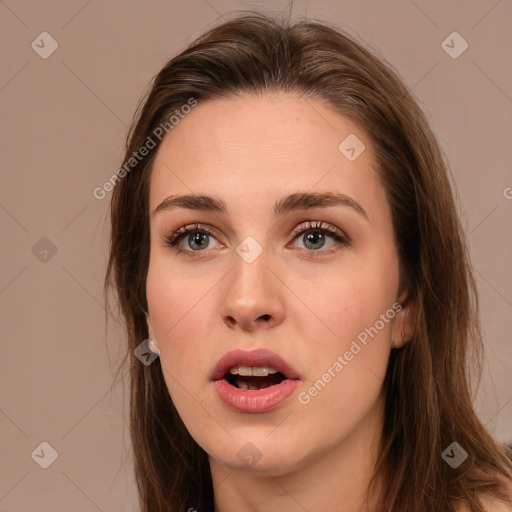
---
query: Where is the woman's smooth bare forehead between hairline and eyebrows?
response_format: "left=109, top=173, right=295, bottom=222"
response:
left=150, top=95, right=386, bottom=226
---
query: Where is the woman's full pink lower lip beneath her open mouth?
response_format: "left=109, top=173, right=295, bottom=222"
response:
left=214, top=379, right=299, bottom=413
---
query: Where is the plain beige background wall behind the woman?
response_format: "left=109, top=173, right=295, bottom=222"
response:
left=0, top=0, right=512, bottom=512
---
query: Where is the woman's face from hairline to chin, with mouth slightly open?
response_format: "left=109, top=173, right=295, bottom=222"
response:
left=147, top=95, right=409, bottom=475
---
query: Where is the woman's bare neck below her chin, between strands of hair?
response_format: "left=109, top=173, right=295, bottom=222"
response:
left=210, top=390, right=384, bottom=512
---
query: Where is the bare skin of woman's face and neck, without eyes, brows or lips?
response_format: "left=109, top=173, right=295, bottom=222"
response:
left=147, top=94, right=414, bottom=512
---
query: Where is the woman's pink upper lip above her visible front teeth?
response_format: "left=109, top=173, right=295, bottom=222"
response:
left=211, top=348, right=300, bottom=380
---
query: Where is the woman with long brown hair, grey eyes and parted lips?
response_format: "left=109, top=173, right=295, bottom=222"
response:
left=106, top=9, right=512, bottom=512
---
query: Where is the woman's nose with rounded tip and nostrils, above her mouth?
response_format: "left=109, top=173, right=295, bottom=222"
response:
left=221, top=251, right=285, bottom=331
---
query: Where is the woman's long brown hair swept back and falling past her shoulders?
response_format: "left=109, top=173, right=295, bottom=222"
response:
left=105, top=12, right=512, bottom=512
